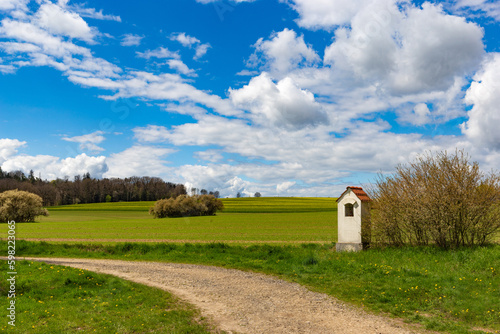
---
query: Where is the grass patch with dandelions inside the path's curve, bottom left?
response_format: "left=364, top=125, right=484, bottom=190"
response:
left=0, top=261, right=219, bottom=334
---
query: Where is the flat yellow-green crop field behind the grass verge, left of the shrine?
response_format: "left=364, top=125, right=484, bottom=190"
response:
left=7, top=198, right=337, bottom=243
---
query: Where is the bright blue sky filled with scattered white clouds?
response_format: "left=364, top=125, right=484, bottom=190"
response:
left=0, top=0, right=500, bottom=196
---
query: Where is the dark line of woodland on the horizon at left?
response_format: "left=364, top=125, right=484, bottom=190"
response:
left=0, top=168, right=187, bottom=206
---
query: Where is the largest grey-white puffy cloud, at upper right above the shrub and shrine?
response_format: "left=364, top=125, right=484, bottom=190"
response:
left=325, top=3, right=484, bottom=95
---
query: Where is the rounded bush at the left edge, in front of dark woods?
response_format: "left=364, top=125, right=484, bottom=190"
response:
left=0, top=190, right=49, bottom=223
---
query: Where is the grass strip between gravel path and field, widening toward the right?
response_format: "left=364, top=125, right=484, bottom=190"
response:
left=7, top=241, right=500, bottom=334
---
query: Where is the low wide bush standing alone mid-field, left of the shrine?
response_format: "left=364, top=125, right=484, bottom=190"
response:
left=149, top=195, right=224, bottom=218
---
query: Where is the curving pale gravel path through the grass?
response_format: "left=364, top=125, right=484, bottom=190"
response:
left=26, top=258, right=417, bottom=334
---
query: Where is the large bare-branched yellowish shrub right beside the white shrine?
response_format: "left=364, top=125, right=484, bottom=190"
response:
left=371, top=151, right=500, bottom=248
